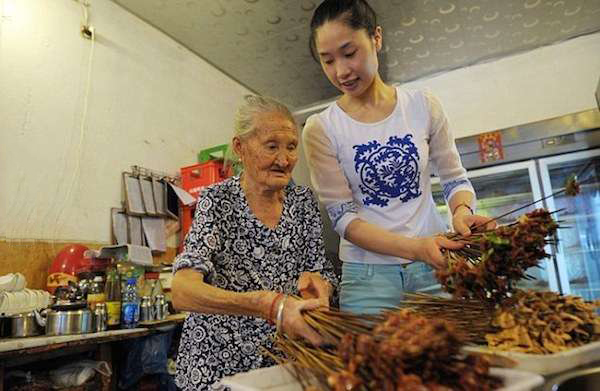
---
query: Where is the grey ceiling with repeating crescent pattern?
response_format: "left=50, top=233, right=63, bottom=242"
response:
left=113, top=0, right=600, bottom=108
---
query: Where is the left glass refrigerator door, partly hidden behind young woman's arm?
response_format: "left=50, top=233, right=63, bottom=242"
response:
left=432, top=161, right=558, bottom=291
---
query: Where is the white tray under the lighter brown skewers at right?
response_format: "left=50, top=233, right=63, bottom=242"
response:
left=463, top=341, right=600, bottom=375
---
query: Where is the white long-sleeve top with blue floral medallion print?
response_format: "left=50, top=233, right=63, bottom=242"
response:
left=302, top=88, right=475, bottom=264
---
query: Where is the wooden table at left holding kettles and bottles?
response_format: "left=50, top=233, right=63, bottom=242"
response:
left=0, top=314, right=186, bottom=391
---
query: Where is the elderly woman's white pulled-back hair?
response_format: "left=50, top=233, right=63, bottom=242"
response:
left=226, top=95, right=296, bottom=166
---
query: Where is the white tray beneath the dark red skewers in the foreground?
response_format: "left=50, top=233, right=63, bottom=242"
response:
left=221, top=365, right=544, bottom=391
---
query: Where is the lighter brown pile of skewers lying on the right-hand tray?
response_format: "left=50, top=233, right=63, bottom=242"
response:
left=402, top=290, right=600, bottom=354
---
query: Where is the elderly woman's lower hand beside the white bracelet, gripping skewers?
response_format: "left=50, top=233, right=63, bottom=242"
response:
left=281, top=297, right=323, bottom=346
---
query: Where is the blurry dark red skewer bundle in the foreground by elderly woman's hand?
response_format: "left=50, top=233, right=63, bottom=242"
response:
left=271, top=309, right=502, bottom=391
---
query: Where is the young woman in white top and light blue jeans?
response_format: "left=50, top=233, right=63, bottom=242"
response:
left=303, top=0, right=489, bottom=313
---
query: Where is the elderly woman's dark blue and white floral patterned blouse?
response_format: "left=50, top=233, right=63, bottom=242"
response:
left=174, top=177, right=336, bottom=391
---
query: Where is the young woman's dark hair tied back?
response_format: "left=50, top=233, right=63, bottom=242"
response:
left=309, top=0, right=377, bottom=62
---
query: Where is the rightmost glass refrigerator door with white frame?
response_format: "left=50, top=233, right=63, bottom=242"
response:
left=540, top=150, right=600, bottom=300
